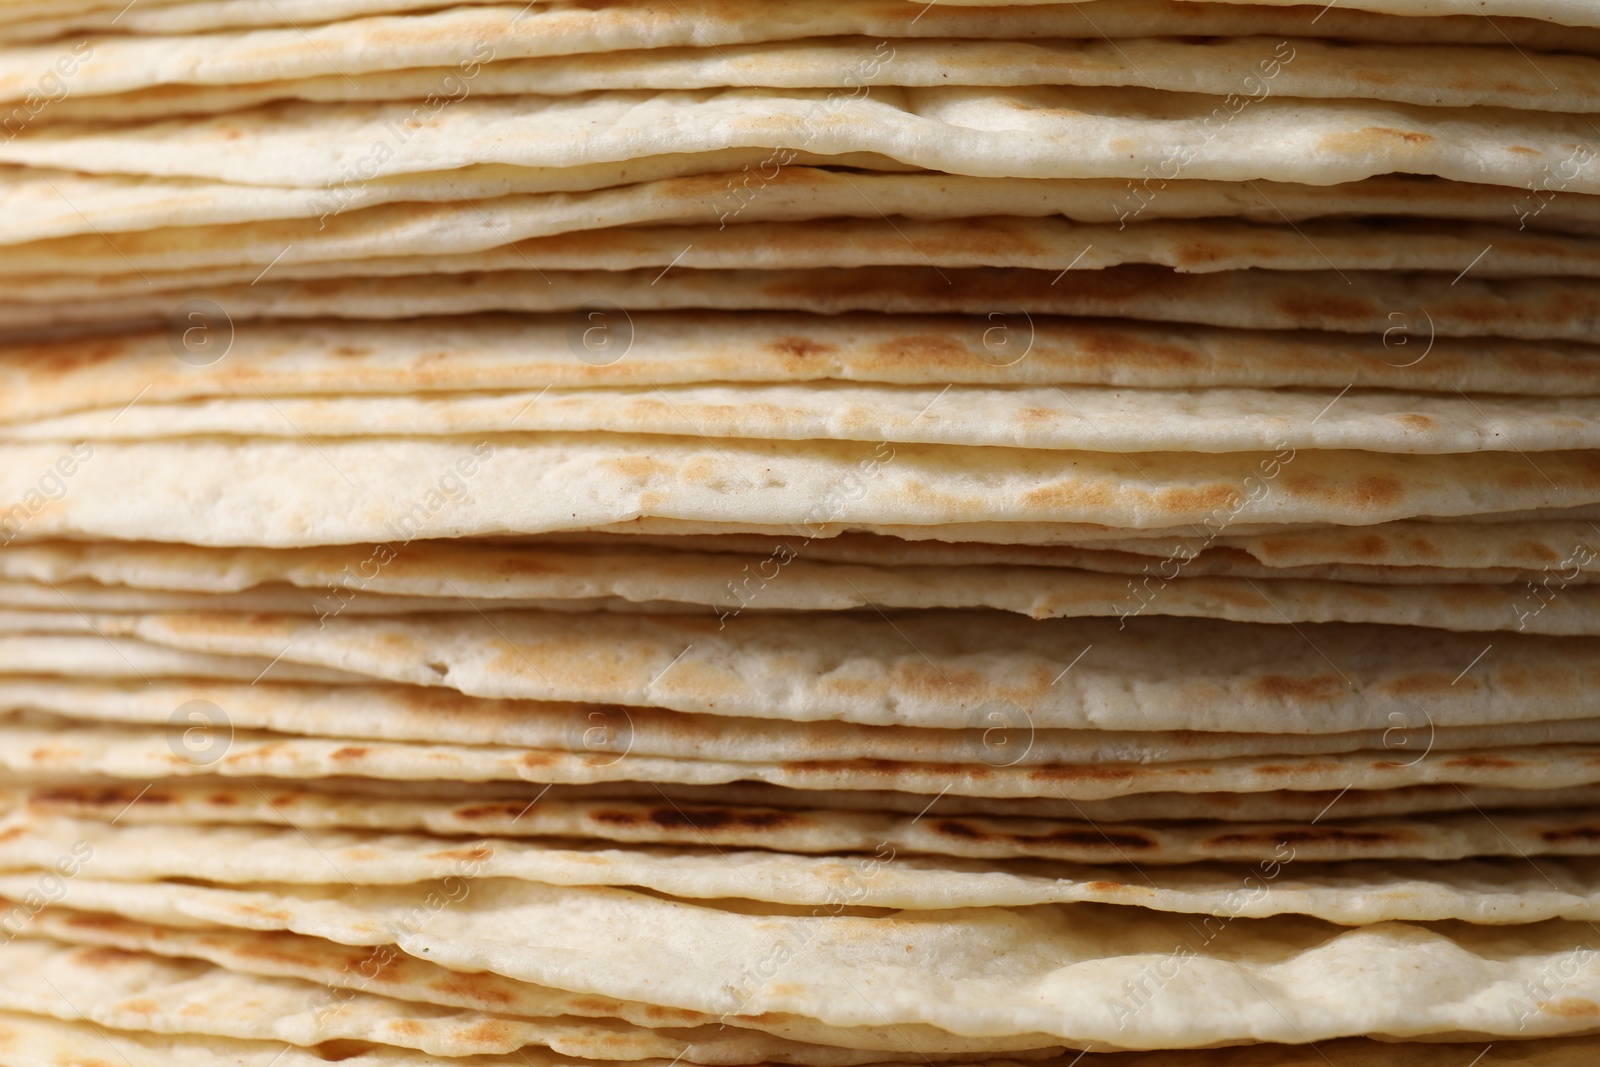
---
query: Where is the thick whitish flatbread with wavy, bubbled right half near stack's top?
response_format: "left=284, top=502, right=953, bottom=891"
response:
left=0, top=88, right=1600, bottom=194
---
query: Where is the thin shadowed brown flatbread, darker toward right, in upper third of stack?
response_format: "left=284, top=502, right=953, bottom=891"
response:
left=0, top=264, right=1600, bottom=337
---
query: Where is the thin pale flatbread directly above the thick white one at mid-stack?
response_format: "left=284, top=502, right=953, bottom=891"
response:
left=9, top=382, right=1600, bottom=454
